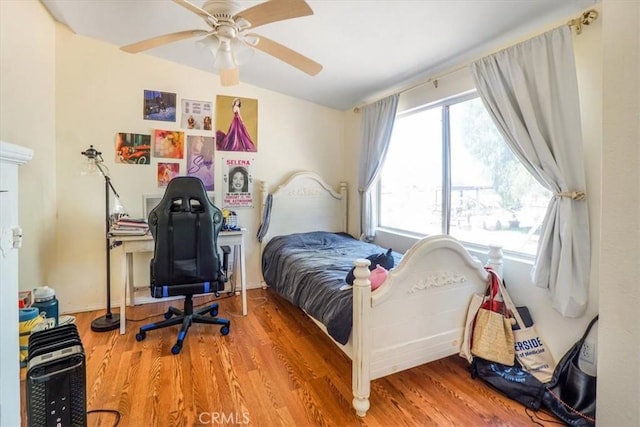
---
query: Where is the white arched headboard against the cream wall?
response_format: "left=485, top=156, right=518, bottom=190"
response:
left=260, top=171, right=347, bottom=245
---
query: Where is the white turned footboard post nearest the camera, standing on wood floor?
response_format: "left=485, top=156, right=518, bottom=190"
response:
left=351, top=259, right=373, bottom=417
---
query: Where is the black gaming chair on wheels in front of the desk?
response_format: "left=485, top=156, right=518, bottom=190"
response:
left=136, top=176, right=231, bottom=354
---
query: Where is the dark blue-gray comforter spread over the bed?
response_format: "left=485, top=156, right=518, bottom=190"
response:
left=262, top=231, right=401, bottom=344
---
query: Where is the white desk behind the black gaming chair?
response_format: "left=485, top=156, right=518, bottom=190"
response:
left=111, top=230, right=247, bottom=334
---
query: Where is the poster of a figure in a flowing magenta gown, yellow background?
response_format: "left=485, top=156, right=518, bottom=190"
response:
left=216, top=95, right=258, bottom=152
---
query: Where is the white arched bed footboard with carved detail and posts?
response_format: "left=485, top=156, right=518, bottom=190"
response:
left=351, top=236, right=502, bottom=417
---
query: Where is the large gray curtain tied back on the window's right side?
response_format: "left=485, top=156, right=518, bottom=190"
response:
left=471, top=26, right=591, bottom=317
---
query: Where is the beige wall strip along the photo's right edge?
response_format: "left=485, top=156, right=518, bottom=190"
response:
left=598, top=0, right=640, bottom=427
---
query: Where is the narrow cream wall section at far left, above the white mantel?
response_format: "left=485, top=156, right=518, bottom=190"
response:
left=0, top=0, right=56, bottom=289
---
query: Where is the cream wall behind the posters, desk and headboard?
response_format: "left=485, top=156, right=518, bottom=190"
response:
left=51, top=25, right=344, bottom=311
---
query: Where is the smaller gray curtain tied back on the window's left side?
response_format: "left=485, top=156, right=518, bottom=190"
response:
left=358, top=94, right=400, bottom=240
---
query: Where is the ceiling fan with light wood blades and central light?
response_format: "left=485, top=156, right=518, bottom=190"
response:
left=120, top=0, right=322, bottom=86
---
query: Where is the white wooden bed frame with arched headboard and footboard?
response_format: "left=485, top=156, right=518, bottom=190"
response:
left=261, top=172, right=502, bottom=417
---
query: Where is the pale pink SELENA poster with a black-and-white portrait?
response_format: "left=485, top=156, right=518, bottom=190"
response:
left=222, top=158, right=253, bottom=208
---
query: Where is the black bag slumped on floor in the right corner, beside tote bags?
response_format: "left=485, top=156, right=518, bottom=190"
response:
left=542, top=316, right=598, bottom=426
